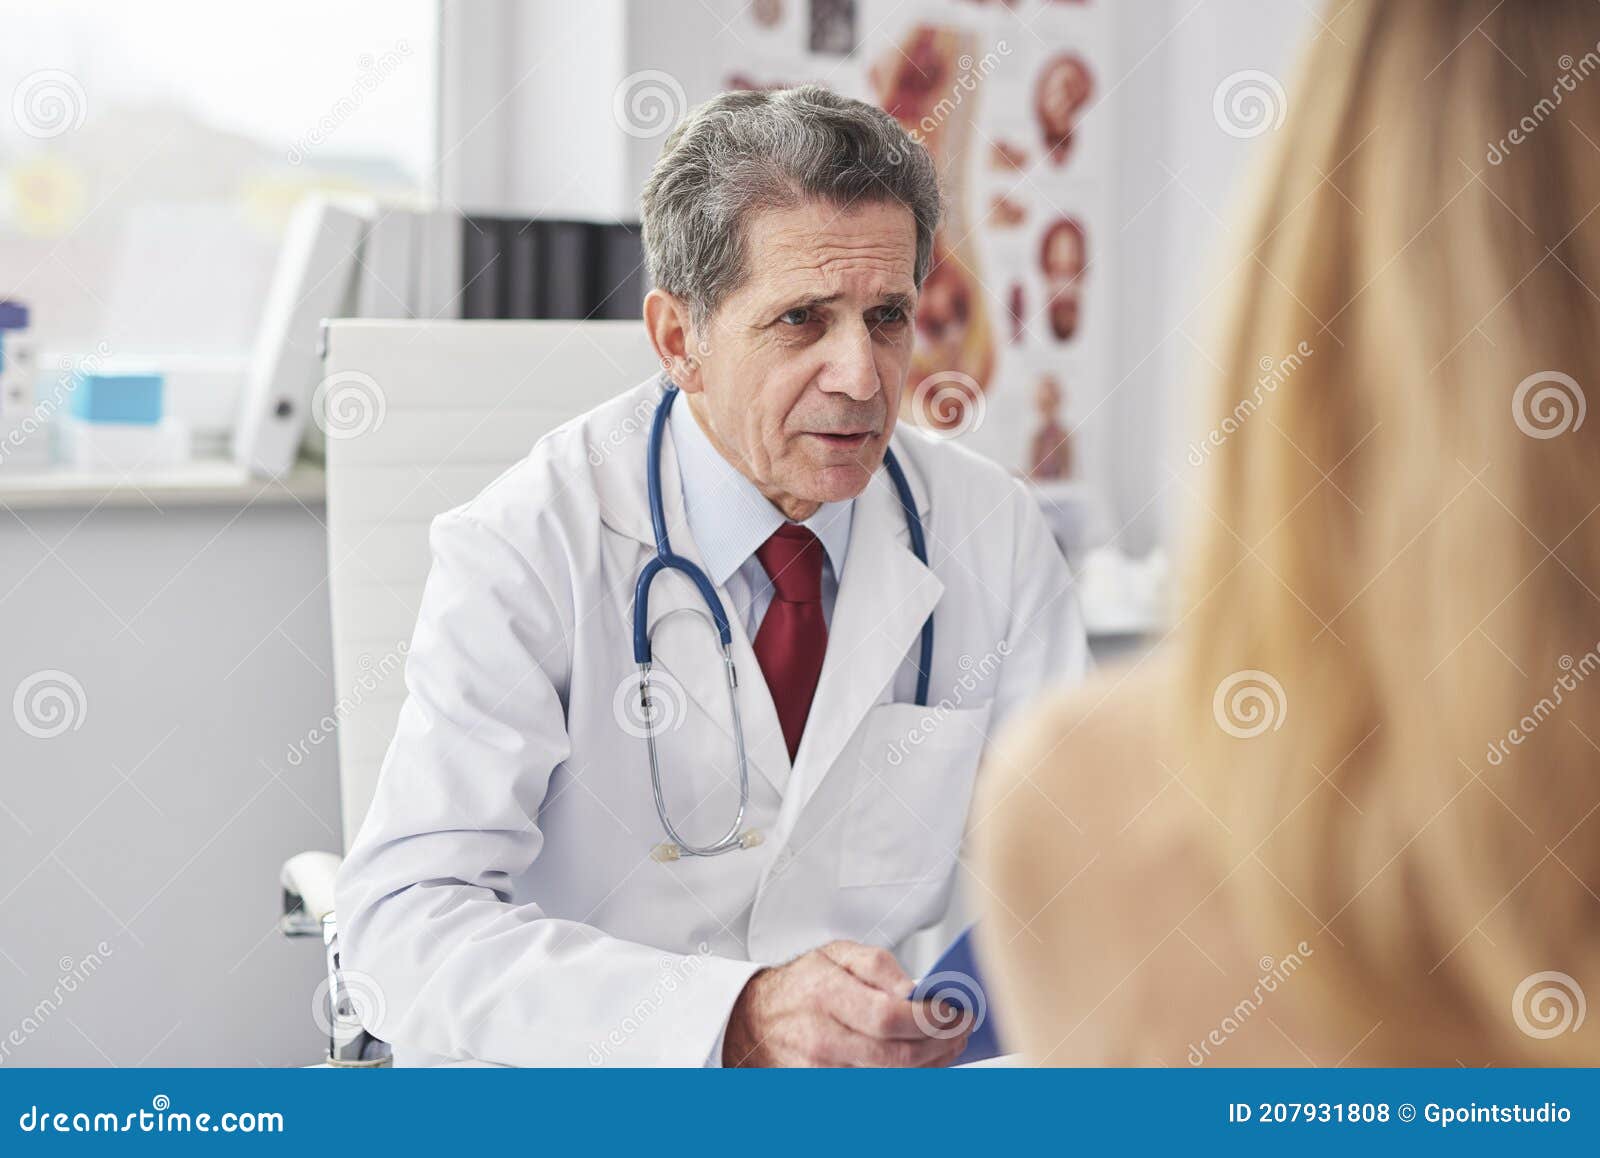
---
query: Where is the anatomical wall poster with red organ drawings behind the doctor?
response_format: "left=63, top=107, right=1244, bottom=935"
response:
left=624, top=0, right=1115, bottom=511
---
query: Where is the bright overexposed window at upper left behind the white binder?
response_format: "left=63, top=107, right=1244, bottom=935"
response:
left=0, top=0, right=438, bottom=449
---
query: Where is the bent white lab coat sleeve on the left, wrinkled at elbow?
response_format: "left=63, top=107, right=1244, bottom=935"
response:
left=336, top=512, right=760, bottom=1065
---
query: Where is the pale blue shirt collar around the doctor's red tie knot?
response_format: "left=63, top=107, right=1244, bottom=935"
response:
left=667, top=398, right=856, bottom=587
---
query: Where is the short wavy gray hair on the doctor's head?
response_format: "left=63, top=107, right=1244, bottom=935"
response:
left=640, top=85, right=944, bottom=329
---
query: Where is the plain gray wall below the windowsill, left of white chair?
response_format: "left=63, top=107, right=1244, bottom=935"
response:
left=0, top=502, right=339, bottom=1065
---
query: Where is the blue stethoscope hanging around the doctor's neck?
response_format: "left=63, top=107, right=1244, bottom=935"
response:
left=634, top=382, right=933, bottom=861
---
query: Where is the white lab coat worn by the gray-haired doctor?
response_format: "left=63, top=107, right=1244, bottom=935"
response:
left=338, top=379, right=1086, bottom=1065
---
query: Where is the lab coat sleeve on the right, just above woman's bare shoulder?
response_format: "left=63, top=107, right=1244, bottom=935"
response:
left=989, top=483, right=1090, bottom=736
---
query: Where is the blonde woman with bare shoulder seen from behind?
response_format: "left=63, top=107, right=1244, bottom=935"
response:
left=974, top=0, right=1600, bottom=1065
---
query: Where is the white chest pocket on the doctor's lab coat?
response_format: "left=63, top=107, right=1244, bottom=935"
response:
left=838, top=704, right=992, bottom=884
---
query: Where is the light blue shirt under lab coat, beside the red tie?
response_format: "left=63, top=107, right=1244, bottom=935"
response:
left=667, top=395, right=856, bottom=640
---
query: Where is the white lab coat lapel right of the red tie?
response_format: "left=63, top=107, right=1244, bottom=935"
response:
left=784, top=454, right=944, bottom=830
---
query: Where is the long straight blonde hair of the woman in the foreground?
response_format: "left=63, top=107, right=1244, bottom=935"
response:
left=1176, top=0, right=1600, bottom=1062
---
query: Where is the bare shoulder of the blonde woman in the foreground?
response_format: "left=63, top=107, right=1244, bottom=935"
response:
left=973, top=656, right=1324, bottom=1065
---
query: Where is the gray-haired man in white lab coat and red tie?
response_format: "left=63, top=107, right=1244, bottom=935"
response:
left=338, top=86, right=1086, bottom=1065
